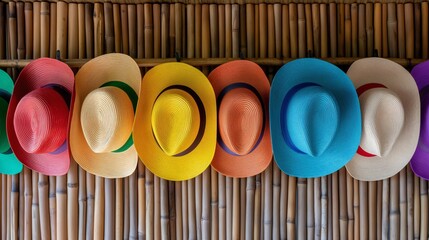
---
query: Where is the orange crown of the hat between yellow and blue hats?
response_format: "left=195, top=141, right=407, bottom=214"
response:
left=219, top=88, right=264, bottom=156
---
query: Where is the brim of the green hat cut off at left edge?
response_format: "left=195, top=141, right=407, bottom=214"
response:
left=0, top=70, right=23, bottom=174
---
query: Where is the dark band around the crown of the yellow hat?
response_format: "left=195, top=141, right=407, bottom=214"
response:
left=152, top=85, right=206, bottom=157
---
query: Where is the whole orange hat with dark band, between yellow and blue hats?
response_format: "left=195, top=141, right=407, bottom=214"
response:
left=208, top=60, right=272, bottom=177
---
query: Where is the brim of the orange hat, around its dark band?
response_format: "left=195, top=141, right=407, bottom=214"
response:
left=208, top=60, right=273, bottom=177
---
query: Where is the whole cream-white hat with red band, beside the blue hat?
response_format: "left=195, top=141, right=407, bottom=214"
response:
left=346, top=58, right=420, bottom=181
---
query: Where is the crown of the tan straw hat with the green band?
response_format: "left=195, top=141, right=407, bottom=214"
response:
left=80, top=86, right=134, bottom=153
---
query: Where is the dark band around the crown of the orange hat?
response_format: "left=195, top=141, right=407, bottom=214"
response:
left=217, top=82, right=266, bottom=156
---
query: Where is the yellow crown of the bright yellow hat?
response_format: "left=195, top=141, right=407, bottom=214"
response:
left=151, top=89, right=200, bottom=156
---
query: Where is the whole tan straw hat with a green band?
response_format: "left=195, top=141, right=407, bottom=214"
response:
left=70, top=53, right=141, bottom=178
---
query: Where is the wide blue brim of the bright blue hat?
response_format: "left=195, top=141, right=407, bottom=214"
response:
left=270, top=59, right=361, bottom=178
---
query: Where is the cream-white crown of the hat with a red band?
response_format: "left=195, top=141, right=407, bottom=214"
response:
left=359, top=88, right=405, bottom=157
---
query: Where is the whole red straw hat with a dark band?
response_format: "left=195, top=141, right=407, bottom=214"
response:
left=6, top=58, right=74, bottom=176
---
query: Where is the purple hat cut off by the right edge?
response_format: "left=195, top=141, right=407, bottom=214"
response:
left=410, top=61, right=429, bottom=180
